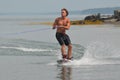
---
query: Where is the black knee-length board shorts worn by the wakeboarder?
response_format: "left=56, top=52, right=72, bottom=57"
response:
left=56, top=32, right=71, bottom=46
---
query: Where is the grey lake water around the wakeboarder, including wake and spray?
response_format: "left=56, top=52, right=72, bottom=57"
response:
left=0, top=15, right=120, bottom=80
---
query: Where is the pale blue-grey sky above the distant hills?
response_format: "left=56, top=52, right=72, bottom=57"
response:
left=0, top=0, right=120, bottom=13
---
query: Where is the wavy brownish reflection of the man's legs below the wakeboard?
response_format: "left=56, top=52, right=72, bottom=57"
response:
left=57, top=66, right=72, bottom=80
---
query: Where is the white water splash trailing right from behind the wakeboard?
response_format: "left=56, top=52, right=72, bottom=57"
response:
left=54, top=42, right=120, bottom=66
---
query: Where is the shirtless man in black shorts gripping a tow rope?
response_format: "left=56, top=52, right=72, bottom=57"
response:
left=53, top=8, right=72, bottom=60
